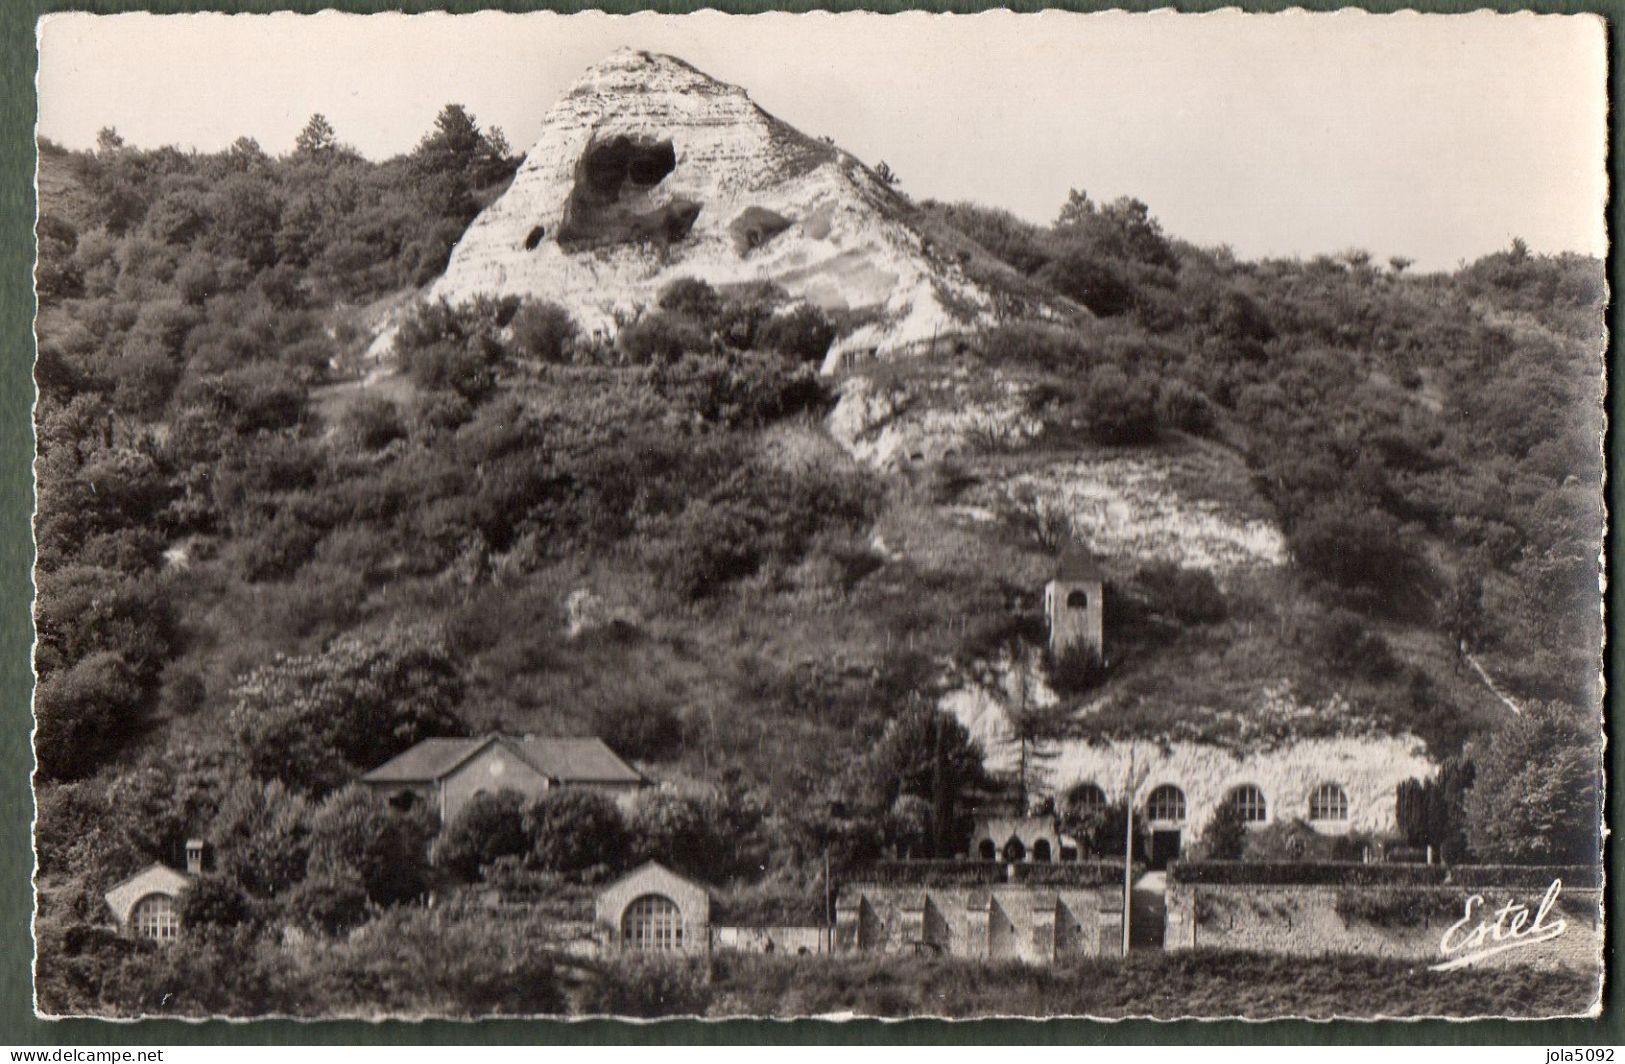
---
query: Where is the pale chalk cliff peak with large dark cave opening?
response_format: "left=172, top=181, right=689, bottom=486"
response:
left=431, top=50, right=993, bottom=367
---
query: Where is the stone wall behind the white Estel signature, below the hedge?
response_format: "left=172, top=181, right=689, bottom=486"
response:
left=1164, top=882, right=1602, bottom=971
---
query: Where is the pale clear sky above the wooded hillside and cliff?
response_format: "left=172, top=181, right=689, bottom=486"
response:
left=39, top=11, right=1607, bottom=270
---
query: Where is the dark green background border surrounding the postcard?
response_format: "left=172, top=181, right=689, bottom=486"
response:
left=0, top=0, right=1625, bottom=1061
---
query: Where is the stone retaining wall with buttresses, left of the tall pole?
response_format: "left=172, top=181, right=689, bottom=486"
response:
left=834, top=884, right=1123, bottom=963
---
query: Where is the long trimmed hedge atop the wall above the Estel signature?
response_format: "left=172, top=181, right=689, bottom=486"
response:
left=1168, top=861, right=1602, bottom=889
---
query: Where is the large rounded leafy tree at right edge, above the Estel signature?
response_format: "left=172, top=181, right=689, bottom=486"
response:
left=1466, top=702, right=1602, bottom=864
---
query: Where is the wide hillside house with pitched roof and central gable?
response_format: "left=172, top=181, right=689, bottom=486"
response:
left=361, top=734, right=648, bottom=822
